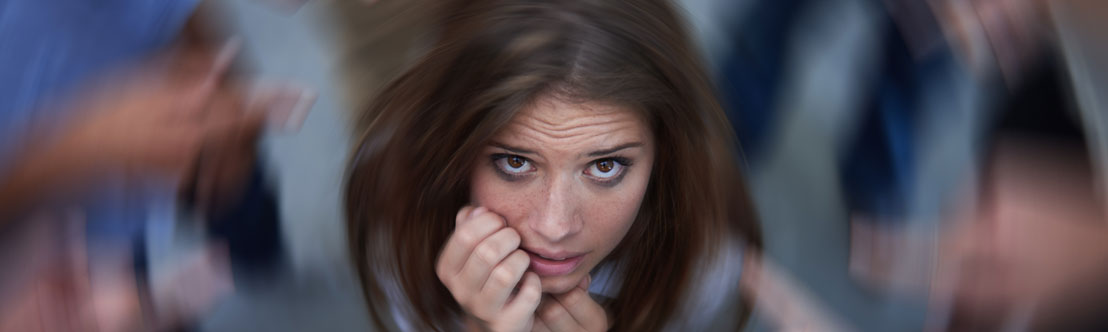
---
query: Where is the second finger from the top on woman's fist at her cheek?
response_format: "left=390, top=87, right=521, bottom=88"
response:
left=458, top=226, right=521, bottom=290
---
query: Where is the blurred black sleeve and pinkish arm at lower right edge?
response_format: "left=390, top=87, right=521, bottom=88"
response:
left=933, top=71, right=1108, bottom=331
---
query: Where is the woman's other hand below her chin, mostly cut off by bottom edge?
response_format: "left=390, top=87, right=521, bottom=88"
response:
left=532, top=277, right=608, bottom=331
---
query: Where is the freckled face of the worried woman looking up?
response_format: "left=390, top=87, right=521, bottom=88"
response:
left=471, top=97, right=654, bottom=293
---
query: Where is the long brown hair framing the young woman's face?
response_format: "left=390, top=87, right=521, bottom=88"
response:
left=346, top=0, right=761, bottom=331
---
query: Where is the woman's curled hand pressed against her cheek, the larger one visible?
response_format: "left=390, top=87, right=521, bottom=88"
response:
left=435, top=207, right=542, bottom=332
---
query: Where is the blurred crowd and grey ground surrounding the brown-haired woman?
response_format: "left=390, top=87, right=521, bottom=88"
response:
left=0, top=0, right=1108, bottom=331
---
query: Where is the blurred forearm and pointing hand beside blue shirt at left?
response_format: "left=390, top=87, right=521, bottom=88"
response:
left=0, top=39, right=315, bottom=221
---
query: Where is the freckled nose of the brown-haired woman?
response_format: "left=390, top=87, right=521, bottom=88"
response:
left=529, top=176, right=584, bottom=243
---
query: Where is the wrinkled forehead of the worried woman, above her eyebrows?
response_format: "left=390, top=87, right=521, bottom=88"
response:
left=496, top=97, right=652, bottom=148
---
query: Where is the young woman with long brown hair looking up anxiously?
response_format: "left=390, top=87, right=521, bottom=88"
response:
left=346, top=0, right=761, bottom=331
